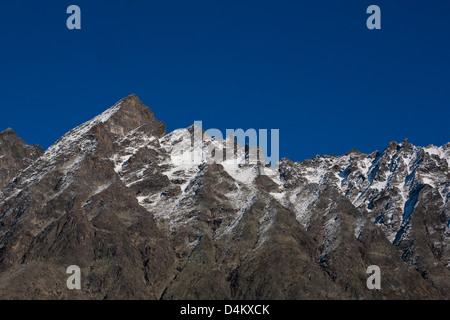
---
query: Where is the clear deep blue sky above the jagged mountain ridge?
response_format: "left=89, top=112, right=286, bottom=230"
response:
left=0, top=0, right=450, bottom=160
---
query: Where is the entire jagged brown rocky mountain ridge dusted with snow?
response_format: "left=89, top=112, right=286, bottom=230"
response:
left=0, top=95, right=450, bottom=299
